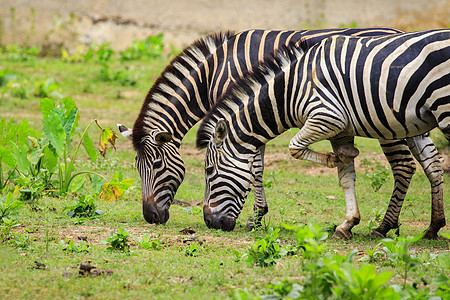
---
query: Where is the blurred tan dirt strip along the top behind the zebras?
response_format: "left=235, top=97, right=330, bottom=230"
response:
left=0, top=0, right=450, bottom=55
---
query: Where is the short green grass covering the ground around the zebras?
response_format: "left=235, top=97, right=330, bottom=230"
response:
left=0, top=45, right=450, bottom=299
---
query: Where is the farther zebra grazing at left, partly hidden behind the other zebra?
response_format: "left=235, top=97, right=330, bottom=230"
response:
left=119, top=28, right=442, bottom=234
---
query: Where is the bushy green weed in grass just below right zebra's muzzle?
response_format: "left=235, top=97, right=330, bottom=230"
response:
left=247, top=228, right=287, bottom=267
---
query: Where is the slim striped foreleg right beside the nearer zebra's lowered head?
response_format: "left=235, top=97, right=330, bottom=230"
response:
left=245, top=146, right=269, bottom=231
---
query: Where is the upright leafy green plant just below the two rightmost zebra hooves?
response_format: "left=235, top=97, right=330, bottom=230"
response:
left=381, top=234, right=424, bottom=287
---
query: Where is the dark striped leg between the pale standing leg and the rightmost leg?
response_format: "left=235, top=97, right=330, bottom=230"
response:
left=370, top=140, right=416, bottom=238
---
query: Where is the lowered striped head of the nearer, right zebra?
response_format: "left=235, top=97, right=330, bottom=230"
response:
left=197, top=119, right=262, bottom=231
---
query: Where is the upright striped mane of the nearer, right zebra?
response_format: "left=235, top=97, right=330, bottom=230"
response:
left=196, top=39, right=312, bottom=149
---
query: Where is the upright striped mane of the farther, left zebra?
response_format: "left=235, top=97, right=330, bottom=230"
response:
left=132, top=31, right=235, bottom=151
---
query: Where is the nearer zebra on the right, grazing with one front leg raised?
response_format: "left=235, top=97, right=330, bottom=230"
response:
left=197, top=29, right=450, bottom=239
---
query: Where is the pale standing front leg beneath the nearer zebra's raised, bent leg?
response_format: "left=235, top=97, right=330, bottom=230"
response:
left=331, top=137, right=361, bottom=239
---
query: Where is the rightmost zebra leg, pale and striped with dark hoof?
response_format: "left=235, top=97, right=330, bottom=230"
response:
left=406, top=134, right=445, bottom=239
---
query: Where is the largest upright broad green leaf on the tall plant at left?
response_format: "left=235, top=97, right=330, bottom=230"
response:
left=42, top=111, right=66, bottom=157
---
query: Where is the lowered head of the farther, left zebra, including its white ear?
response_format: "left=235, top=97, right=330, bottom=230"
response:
left=118, top=124, right=185, bottom=224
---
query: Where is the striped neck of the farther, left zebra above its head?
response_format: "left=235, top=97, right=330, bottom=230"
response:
left=135, top=45, right=221, bottom=147
